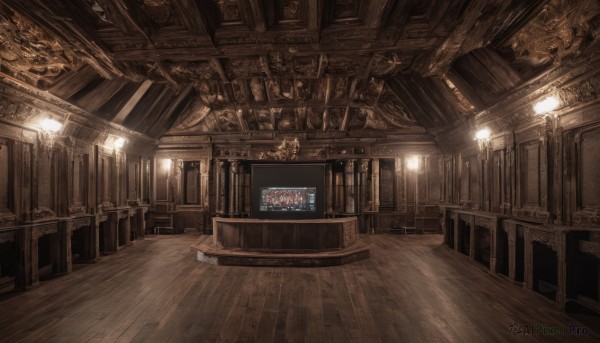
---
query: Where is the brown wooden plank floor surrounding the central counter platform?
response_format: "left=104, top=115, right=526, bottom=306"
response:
left=0, top=235, right=600, bottom=342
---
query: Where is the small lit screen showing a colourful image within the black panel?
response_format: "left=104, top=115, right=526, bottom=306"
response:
left=259, top=187, right=317, bottom=212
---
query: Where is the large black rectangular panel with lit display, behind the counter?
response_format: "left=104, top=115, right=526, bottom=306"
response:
left=251, top=163, right=325, bottom=219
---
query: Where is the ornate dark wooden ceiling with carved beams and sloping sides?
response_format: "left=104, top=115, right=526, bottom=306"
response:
left=0, top=0, right=598, bottom=144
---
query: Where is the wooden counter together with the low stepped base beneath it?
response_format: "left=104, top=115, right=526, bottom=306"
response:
left=192, top=217, right=370, bottom=267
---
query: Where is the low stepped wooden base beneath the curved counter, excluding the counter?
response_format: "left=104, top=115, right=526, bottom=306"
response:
left=192, top=236, right=371, bottom=267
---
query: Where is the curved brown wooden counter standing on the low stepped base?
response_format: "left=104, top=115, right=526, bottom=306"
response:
left=213, top=217, right=358, bottom=252
